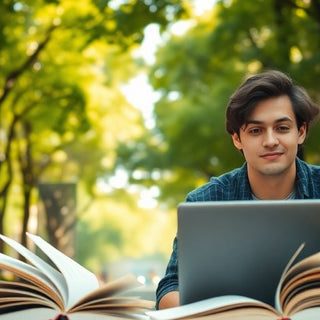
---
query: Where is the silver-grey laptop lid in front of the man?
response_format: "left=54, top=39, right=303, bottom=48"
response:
left=178, top=200, right=320, bottom=305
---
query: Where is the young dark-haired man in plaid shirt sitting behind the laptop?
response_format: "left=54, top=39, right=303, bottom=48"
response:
left=156, top=71, right=320, bottom=309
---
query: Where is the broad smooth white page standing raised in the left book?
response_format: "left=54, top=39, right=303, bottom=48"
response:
left=27, top=233, right=99, bottom=310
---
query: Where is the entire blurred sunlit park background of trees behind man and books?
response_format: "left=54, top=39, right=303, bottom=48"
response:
left=0, top=0, right=320, bottom=300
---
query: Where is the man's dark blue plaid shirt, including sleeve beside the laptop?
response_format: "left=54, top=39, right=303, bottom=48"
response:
left=156, top=158, right=320, bottom=308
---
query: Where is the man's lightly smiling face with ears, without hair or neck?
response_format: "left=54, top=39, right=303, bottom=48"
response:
left=232, top=96, right=306, bottom=176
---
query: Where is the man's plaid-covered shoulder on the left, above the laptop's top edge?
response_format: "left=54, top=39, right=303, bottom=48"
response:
left=187, top=164, right=251, bottom=201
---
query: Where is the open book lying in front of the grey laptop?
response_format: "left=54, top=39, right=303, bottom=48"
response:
left=147, top=245, right=320, bottom=320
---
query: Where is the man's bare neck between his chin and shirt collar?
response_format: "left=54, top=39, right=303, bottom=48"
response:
left=248, top=167, right=296, bottom=200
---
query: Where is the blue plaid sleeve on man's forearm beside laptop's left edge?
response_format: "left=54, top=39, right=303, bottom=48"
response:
left=156, top=237, right=179, bottom=309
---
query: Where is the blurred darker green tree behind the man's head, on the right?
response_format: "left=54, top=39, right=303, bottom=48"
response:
left=115, top=0, right=320, bottom=205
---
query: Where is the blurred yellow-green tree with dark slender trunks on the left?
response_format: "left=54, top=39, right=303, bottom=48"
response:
left=0, top=0, right=183, bottom=250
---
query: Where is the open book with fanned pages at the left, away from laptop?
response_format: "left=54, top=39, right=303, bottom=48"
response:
left=0, top=233, right=154, bottom=320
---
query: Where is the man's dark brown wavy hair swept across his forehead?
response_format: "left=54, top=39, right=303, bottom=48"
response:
left=226, top=70, right=319, bottom=135
